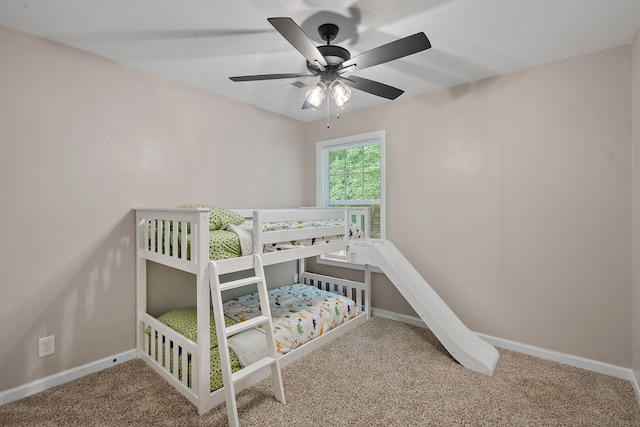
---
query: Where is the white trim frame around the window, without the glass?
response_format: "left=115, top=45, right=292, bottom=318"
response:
left=316, top=130, right=387, bottom=269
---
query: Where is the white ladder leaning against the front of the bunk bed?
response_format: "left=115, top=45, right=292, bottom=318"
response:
left=209, top=254, right=285, bottom=426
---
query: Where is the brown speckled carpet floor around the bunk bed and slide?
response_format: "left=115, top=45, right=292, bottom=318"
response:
left=0, top=317, right=640, bottom=426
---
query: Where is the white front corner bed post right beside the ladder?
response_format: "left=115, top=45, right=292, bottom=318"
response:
left=191, top=210, right=212, bottom=415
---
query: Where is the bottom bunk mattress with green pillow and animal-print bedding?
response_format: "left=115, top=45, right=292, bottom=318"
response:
left=146, top=284, right=358, bottom=391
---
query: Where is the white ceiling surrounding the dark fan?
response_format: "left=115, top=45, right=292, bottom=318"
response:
left=0, top=0, right=640, bottom=121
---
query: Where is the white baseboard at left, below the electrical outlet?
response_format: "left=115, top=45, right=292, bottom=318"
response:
left=0, top=350, right=136, bottom=405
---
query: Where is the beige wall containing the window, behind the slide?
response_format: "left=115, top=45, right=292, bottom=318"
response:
left=306, top=46, right=632, bottom=367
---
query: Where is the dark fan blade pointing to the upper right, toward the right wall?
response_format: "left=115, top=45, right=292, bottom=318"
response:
left=342, top=33, right=431, bottom=71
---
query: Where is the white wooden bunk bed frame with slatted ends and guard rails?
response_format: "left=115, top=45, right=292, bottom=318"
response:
left=136, top=208, right=371, bottom=420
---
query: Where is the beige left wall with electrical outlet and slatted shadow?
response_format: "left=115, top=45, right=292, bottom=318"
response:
left=0, top=27, right=304, bottom=390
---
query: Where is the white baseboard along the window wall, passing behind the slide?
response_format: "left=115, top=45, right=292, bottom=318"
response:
left=371, top=308, right=640, bottom=384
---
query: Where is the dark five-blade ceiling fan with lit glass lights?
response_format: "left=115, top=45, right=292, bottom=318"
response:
left=229, top=18, right=431, bottom=110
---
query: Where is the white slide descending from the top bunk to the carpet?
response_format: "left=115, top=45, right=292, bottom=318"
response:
left=349, top=239, right=500, bottom=375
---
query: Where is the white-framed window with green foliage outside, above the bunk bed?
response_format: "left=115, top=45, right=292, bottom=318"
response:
left=316, top=131, right=386, bottom=244
